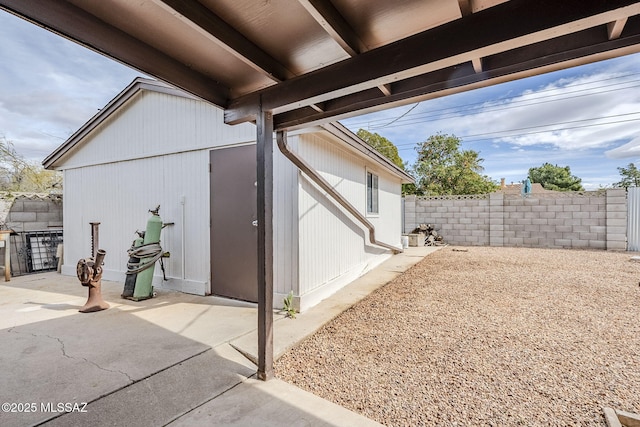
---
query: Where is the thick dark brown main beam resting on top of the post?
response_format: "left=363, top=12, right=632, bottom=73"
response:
left=225, top=0, right=640, bottom=124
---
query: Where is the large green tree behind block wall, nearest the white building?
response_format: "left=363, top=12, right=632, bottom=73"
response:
left=413, top=133, right=498, bottom=195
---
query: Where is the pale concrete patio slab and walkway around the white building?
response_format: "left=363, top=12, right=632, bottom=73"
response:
left=0, top=248, right=435, bottom=427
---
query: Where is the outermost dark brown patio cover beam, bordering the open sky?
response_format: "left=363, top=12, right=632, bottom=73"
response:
left=274, top=22, right=640, bottom=130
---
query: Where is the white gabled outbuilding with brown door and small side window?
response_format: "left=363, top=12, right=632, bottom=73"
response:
left=43, top=78, right=412, bottom=310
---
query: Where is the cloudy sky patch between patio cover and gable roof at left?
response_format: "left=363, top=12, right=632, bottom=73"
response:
left=0, top=11, right=139, bottom=161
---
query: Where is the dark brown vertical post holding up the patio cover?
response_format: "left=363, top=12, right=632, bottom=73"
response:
left=256, top=102, right=273, bottom=381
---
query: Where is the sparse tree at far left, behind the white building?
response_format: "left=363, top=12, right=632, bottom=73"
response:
left=0, top=136, right=62, bottom=192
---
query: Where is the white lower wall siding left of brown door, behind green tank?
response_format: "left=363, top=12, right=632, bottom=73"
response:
left=64, top=150, right=210, bottom=293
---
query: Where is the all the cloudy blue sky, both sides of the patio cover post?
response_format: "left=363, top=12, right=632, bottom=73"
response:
left=0, top=11, right=640, bottom=190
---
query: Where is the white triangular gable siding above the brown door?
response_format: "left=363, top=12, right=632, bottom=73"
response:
left=59, top=91, right=256, bottom=169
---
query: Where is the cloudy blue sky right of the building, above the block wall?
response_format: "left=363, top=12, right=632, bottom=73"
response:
left=344, top=55, right=640, bottom=188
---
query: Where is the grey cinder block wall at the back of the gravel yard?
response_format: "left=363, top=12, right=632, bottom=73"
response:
left=405, top=189, right=627, bottom=250
